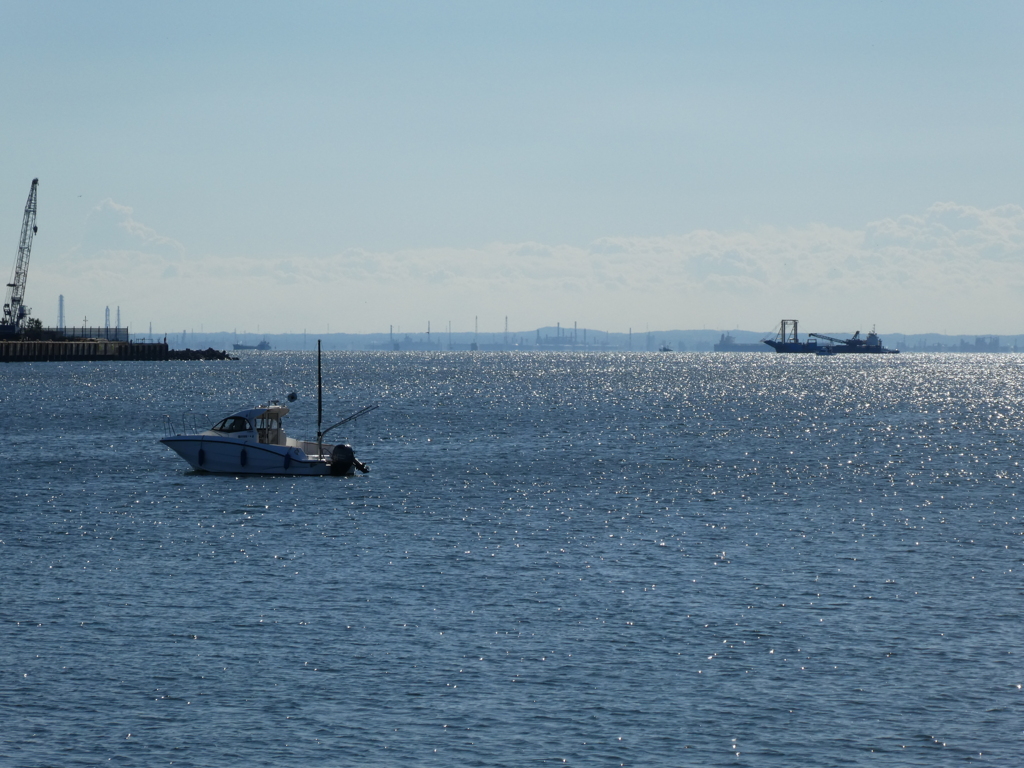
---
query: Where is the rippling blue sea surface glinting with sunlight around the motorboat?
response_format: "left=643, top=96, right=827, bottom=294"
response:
left=0, top=352, right=1024, bottom=766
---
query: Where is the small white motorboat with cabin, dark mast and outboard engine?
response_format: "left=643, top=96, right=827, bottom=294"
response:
left=161, top=342, right=377, bottom=475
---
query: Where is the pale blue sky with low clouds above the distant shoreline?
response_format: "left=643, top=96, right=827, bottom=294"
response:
left=0, top=0, right=1024, bottom=335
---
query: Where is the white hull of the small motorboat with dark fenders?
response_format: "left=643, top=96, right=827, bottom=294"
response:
left=161, top=435, right=352, bottom=475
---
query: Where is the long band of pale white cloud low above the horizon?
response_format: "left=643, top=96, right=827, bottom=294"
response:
left=25, top=201, right=1024, bottom=334
